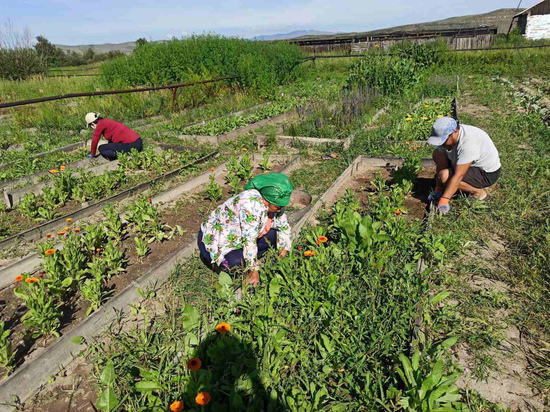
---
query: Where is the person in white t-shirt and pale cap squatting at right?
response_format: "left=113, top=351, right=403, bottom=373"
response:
left=428, top=117, right=500, bottom=214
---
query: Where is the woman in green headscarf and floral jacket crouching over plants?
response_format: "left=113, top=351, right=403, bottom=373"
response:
left=197, top=173, right=292, bottom=286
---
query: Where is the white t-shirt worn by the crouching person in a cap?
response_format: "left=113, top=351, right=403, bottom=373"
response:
left=438, top=124, right=500, bottom=173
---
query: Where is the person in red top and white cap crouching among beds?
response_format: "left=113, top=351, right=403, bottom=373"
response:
left=86, top=113, right=143, bottom=160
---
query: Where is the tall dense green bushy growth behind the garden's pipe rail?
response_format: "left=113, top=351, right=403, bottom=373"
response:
left=101, top=35, right=303, bottom=94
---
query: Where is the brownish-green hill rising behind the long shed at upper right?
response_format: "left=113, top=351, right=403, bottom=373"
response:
left=297, top=9, right=524, bottom=40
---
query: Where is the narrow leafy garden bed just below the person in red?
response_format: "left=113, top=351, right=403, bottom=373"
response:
left=0, top=148, right=218, bottom=248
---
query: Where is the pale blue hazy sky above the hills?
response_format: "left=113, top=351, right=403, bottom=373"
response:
left=0, top=0, right=539, bottom=45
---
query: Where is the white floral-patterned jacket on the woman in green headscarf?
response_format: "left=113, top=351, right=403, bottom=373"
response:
left=201, top=189, right=292, bottom=270
